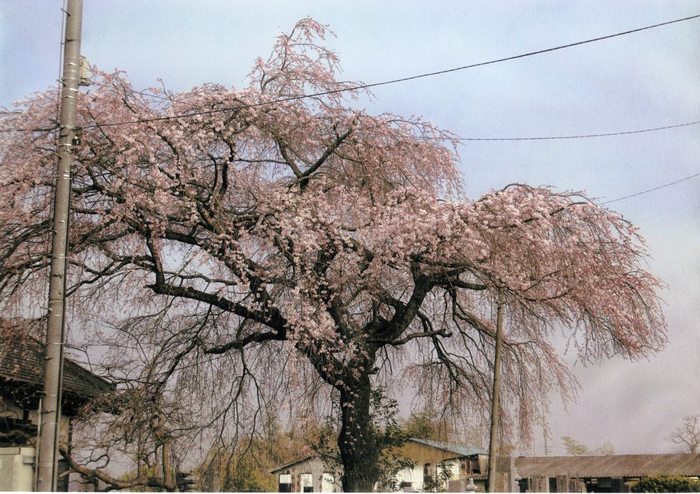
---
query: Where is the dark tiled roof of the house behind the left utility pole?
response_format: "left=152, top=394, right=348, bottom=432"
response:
left=0, top=332, right=115, bottom=399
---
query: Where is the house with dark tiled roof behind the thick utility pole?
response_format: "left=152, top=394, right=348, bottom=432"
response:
left=0, top=328, right=114, bottom=491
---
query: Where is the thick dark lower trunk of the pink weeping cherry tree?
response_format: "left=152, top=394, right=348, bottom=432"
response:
left=338, top=372, right=379, bottom=492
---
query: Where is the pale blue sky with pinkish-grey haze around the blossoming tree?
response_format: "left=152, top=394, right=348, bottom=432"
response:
left=0, top=0, right=700, bottom=454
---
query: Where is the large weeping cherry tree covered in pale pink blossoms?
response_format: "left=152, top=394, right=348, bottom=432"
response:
left=0, top=19, right=665, bottom=491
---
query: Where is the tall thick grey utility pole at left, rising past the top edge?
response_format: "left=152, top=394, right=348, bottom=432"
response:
left=37, top=0, right=83, bottom=491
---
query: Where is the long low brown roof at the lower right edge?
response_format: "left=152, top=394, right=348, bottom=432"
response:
left=515, top=453, right=700, bottom=478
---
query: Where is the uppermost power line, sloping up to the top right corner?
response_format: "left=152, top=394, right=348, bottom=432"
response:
left=0, top=14, right=700, bottom=132
